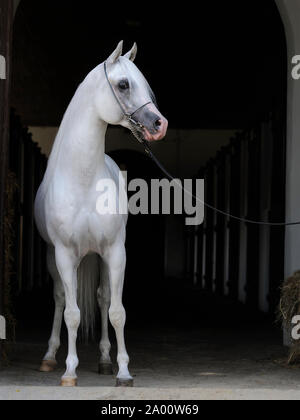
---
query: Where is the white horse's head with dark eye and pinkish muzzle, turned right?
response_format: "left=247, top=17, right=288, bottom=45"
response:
left=99, top=41, right=168, bottom=141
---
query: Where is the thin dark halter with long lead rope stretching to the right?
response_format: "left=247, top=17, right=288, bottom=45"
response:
left=104, top=62, right=300, bottom=227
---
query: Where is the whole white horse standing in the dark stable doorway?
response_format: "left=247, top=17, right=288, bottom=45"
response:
left=35, top=41, right=168, bottom=386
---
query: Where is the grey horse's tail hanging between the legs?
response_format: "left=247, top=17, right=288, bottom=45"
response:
left=77, top=254, right=100, bottom=341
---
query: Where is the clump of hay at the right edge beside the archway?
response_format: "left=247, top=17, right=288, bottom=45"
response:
left=278, top=271, right=300, bottom=365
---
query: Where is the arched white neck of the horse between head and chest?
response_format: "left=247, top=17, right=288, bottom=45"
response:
left=45, top=77, right=107, bottom=190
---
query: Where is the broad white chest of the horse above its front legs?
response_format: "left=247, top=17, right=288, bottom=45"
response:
left=45, top=165, right=126, bottom=254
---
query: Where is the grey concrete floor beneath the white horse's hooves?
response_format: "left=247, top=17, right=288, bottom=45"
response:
left=0, top=325, right=300, bottom=400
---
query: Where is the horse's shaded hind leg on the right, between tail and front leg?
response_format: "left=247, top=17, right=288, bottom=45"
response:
left=97, top=261, right=113, bottom=375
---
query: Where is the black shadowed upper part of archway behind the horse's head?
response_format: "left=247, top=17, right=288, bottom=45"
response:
left=13, top=0, right=286, bottom=128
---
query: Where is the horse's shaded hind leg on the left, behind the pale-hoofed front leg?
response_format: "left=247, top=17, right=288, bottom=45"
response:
left=40, top=246, right=65, bottom=372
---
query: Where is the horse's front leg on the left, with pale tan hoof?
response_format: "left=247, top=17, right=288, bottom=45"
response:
left=55, top=246, right=80, bottom=386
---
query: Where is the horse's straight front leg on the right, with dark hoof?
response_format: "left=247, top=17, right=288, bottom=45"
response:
left=105, top=241, right=133, bottom=386
